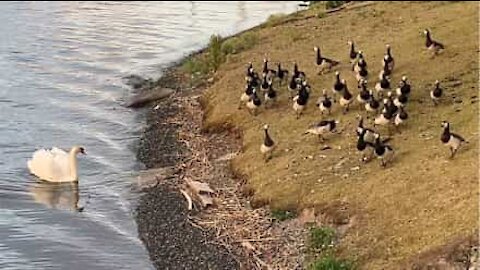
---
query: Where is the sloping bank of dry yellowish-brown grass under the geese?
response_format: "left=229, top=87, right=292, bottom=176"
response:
left=178, top=2, right=479, bottom=269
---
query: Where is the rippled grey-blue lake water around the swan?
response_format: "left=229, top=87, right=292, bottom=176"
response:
left=0, top=2, right=297, bottom=270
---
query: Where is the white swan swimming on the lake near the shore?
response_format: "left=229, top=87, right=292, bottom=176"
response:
left=27, top=146, right=85, bottom=182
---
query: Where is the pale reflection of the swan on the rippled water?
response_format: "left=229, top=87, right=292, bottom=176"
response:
left=30, top=181, right=83, bottom=212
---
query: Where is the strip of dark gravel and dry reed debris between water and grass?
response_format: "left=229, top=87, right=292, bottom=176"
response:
left=135, top=56, right=306, bottom=269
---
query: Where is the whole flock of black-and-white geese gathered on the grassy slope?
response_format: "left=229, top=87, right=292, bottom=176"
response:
left=239, top=29, right=467, bottom=167
